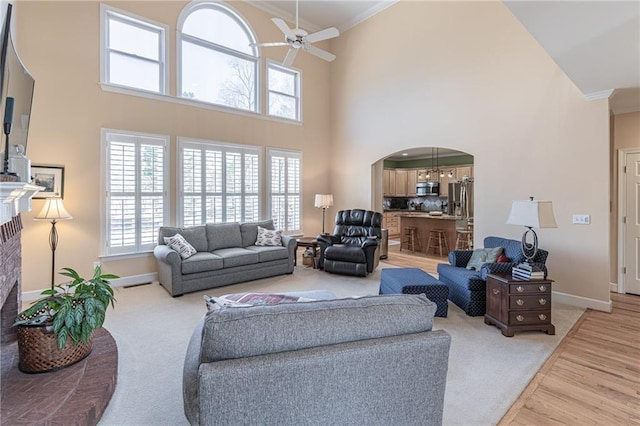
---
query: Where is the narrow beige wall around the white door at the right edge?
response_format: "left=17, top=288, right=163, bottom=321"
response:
left=610, top=112, right=640, bottom=284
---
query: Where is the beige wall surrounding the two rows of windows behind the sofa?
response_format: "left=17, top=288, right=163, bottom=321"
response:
left=15, top=1, right=330, bottom=291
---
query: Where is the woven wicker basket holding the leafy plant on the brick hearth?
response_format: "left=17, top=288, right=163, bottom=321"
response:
left=16, top=325, right=93, bottom=373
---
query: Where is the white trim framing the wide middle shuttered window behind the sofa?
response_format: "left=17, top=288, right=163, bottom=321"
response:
left=175, top=136, right=264, bottom=226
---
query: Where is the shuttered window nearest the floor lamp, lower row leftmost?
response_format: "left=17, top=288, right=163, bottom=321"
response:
left=102, top=129, right=169, bottom=255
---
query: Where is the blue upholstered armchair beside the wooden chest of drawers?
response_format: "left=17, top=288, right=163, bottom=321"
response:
left=438, top=237, right=549, bottom=316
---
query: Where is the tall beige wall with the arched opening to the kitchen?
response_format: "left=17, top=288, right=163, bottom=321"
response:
left=331, top=1, right=609, bottom=309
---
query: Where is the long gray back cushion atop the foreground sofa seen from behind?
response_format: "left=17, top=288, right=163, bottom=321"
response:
left=200, top=294, right=436, bottom=363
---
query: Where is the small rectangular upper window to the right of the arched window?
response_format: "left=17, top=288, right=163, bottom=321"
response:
left=267, top=62, right=300, bottom=121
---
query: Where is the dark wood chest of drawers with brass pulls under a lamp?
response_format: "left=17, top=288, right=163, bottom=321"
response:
left=484, top=274, right=556, bottom=337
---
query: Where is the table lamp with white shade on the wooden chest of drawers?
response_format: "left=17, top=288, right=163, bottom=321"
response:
left=507, top=197, right=558, bottom=270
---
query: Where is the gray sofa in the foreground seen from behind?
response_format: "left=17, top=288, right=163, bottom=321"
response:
left=183, top=295, right=451, bottom=425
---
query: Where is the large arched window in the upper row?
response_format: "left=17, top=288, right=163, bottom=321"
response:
left=178, top=2, right=258, bottom=112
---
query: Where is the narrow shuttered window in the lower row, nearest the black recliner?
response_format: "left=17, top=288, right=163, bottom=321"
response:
left=267, top=148, right=302, bottom=234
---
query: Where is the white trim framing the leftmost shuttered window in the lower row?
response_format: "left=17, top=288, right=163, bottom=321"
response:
left=100, top=128, right=171, bottom=259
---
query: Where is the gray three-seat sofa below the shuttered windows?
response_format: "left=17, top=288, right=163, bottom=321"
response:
left=153, top=220, right=297, bottom=297
